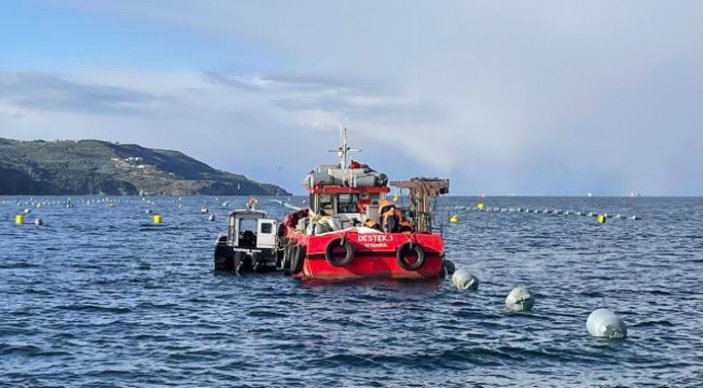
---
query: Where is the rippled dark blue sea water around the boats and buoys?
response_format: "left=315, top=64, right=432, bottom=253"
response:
left=0, top=196, right=703, bottom=387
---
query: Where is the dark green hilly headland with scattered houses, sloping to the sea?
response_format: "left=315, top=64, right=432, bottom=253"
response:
left=0, top=138, right=290, bottom=195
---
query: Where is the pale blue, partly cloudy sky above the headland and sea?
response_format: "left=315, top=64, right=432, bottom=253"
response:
left=0, top=0, right=703, bottom=195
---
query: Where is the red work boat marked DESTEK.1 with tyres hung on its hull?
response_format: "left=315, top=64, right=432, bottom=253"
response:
left=279, top=128, right=449, bottom=280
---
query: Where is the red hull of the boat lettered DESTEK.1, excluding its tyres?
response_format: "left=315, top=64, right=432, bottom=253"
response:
left=288, top=230, right=444, bottom=280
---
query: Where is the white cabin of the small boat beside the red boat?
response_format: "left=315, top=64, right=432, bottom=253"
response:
left=227, top=209, right=276, bottom=250
